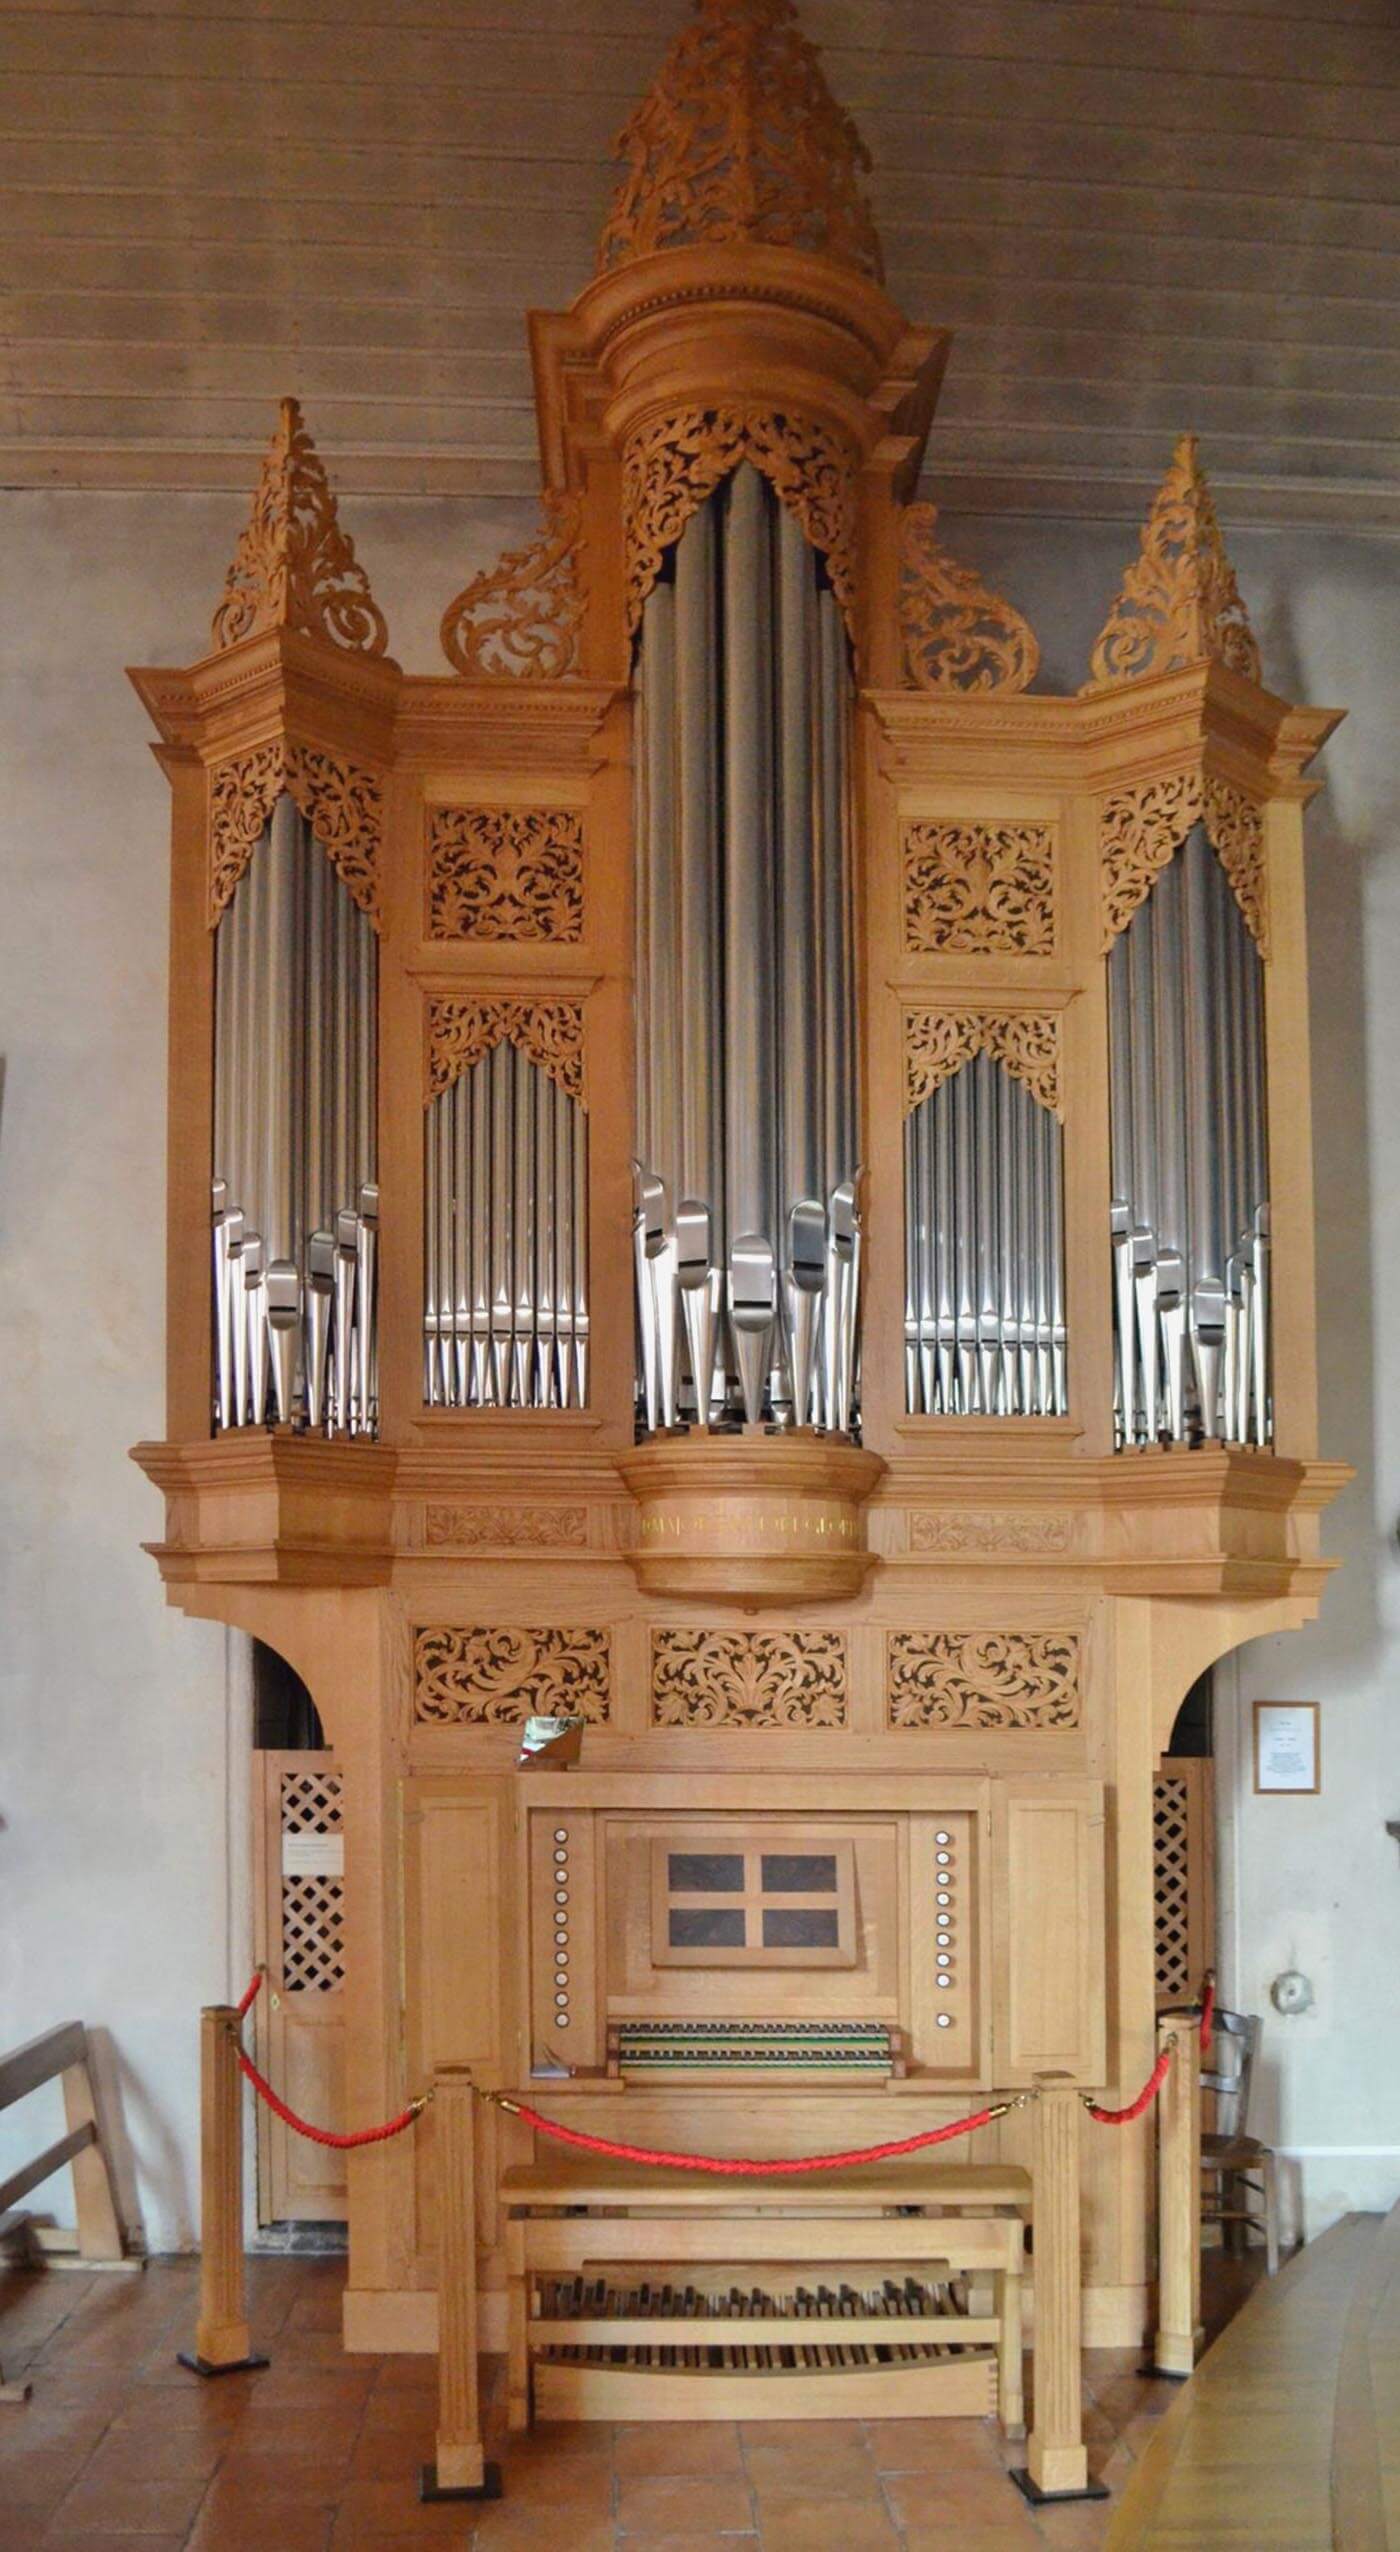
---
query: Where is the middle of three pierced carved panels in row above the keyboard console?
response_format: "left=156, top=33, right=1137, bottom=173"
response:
left=650, top=1631, right=847, bottom=1728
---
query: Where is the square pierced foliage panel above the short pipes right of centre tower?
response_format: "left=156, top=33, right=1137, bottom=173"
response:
left=903, top=824, right=1056, bottom=957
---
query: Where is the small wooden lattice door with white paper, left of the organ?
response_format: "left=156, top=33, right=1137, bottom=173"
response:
left=252, top=1748, right=347, bottom=2225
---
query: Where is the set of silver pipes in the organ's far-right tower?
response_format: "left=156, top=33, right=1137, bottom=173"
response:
left=1109, top=824, right=1272, bottom=1444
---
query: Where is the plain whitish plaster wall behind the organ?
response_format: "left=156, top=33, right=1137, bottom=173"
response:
left=0, top=493, right=1400, bottom=2248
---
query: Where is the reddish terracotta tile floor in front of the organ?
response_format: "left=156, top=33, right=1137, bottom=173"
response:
left=0, top=2259, right=1252, bottom=2552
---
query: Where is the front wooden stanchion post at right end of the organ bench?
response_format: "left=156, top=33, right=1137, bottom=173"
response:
left=1012, top=2075, right=1109, bottom=2504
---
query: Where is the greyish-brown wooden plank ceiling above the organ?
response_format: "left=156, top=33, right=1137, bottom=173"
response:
left=0, top=0, right=1400, bottom=531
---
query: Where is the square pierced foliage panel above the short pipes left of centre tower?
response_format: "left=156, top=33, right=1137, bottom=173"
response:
left=428, top=806, right=584, bottom=944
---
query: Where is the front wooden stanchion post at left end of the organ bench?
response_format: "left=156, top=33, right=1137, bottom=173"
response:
left=418, top=2065, right=500, bottom=2498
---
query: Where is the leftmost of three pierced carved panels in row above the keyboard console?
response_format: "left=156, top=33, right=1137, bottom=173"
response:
left=413, top=1628, right=612, bottom=1728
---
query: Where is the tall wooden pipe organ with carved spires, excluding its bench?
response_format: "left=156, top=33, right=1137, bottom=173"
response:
left=135, top=0, right=1339, bottom=2449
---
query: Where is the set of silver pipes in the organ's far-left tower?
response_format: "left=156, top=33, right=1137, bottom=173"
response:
left=214, top=796, right=377, bottom=1434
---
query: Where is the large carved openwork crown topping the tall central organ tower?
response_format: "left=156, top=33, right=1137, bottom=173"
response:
left=599, top=0, right=882, bottom=281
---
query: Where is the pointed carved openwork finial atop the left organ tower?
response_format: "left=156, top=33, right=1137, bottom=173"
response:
left=214, top=398, right=388, bottom=656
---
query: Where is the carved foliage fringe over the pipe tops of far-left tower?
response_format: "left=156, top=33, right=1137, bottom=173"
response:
left=209, top=738, right=385, bottom=929
